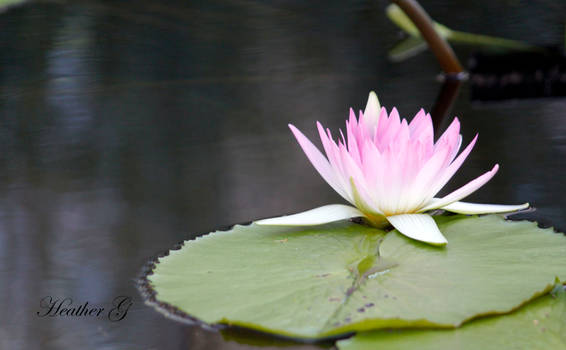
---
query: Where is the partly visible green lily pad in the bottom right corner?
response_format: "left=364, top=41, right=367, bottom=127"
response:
left=338, top=286, right=566, bottom=350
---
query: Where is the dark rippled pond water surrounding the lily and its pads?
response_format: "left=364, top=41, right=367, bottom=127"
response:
left=0, top=0, right=566, bottom=349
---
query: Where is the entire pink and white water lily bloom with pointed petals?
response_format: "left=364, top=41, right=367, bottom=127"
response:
left=258, top=92, right=529, bottom=245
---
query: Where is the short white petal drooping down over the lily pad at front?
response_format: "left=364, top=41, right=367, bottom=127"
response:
left=387, top=214, right=448, bottom=245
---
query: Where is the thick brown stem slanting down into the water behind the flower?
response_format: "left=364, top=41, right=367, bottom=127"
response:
left=392, top=0, right=463, bottom=74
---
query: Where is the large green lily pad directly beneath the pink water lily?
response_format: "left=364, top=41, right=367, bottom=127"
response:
left=147, top=215, right=566, bottom=339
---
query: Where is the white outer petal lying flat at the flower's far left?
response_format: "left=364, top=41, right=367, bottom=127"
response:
left=255, top=204, right=364, bottom=226
